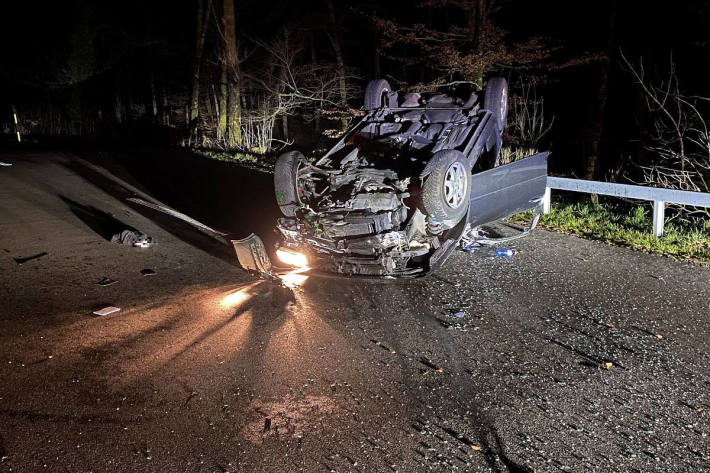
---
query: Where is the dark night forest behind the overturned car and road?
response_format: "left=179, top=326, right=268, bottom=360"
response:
left=0, top=0, right=710, bottom=191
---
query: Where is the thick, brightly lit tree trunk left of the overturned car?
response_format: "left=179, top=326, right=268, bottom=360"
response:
left=222, top=0, right=242, bottom=146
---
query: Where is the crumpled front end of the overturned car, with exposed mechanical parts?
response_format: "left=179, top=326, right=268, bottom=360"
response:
left=277, top=148, right=439, bottom=276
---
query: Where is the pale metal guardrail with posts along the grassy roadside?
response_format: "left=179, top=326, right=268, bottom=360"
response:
left=542, top=177, right=710, bottom=237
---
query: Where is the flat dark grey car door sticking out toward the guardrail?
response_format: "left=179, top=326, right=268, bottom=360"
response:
left=468, top=151, right=550, bottom=227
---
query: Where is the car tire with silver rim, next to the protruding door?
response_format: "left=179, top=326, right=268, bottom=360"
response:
left=422, top=149, right=471, bottom=228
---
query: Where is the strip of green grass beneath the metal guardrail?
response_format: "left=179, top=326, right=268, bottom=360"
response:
left=512, top=203, right=710, bottom=265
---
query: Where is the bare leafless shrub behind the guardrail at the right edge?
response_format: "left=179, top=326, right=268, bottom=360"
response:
left=621, top=53, right=710, bottom=214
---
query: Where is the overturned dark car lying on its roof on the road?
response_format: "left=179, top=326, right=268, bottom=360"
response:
left=235, top=78, right=547, bottom=277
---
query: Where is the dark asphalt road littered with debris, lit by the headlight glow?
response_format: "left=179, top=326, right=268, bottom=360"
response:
left=0, top=153, right=710, bottom=473
